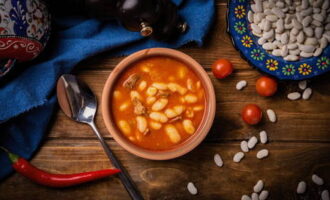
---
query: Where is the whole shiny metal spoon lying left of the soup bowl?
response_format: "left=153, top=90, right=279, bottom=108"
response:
left=57, top=74, right=143, bottom=200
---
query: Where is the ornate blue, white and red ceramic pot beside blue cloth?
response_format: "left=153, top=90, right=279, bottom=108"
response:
left=0, top=0, right=51, bottom=79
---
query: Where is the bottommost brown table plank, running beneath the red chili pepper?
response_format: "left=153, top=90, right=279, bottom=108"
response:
left=0, top=140, right=330, bottom=200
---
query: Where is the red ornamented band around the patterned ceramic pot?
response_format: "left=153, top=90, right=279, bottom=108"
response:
left=0, top=37, right=43, bottom=62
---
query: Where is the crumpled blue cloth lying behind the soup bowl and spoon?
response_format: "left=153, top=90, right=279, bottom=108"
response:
left=0, top=0, right=214, bottom=180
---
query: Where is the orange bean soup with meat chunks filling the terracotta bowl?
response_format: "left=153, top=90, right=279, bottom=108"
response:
left=111, top=56, right=205, bottom=150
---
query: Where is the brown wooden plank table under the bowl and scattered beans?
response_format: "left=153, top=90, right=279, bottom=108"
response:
left=0, top=0, right=330, bottom=200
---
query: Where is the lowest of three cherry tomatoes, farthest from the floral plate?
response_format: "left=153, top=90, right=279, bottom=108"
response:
left=241, top=104, right=262, bottom=125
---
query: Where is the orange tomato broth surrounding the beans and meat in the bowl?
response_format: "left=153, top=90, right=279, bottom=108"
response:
left=111, top=56, right=205, bottom=150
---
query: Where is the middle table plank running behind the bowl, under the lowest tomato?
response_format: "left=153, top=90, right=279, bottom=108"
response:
left=49, top=70, right=330, bottom=142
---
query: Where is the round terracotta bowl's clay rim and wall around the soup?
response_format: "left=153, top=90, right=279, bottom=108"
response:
left=102, top=48, right=216, bottom=160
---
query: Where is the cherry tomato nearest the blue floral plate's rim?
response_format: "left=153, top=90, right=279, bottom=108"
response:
left=256, top=76, right=277, bottom=97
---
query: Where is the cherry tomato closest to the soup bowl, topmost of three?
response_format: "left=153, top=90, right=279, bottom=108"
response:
left=212, top=59, right=233, bottom=79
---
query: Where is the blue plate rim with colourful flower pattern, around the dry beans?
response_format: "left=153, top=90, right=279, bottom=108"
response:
left=227, top=0, right=330, bottom=80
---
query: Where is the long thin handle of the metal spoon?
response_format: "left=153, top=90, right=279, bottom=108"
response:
left=89, top=122, right=143, bottom=200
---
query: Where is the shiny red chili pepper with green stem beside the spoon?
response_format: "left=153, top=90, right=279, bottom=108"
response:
left=0, top=147, right=120, bottom=188
